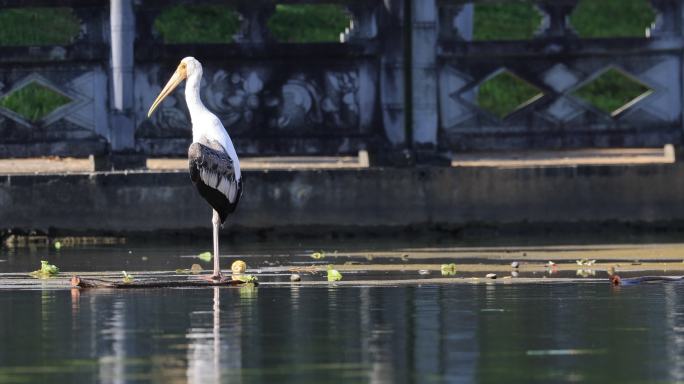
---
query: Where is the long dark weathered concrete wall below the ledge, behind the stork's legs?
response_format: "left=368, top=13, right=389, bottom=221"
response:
left=0, top=163, right=684, bottom=233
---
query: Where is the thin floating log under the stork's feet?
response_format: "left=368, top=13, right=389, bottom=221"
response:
left=71, top=276, right=258, bottom=288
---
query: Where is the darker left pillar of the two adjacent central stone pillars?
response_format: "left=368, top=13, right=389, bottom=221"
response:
left=379, top=0, right=411, bottom=147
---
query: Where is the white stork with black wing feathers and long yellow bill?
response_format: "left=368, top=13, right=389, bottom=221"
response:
left=147, top=57, right=242, bottom=281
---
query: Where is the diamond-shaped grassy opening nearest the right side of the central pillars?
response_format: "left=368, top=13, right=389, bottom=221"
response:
left=477, top=70, right=544, bottom=119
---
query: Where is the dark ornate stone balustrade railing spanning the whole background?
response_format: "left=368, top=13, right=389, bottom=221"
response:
left=0, top=0, right=684, bottom=164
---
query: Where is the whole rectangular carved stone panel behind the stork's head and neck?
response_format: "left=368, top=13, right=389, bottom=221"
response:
left=135, top=62, right=376, bottom=154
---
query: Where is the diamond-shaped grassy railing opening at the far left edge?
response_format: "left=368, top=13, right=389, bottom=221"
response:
left=0, top=81, right=71, bottom=122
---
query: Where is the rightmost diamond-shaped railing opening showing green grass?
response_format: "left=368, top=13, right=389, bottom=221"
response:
left=572, top=67, right=653, bottom=116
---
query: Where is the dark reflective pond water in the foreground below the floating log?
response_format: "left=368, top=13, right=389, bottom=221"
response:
left=0, top=283, right=684, bottom=383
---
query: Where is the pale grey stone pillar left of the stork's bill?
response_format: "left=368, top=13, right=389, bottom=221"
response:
left=109, top=0, right=135, bottom=151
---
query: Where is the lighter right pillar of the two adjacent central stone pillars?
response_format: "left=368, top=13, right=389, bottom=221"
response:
left=411, top=0, right=439, bottom=149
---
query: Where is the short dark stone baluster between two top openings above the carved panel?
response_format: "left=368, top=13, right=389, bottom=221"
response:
left=235, top=1, right=275, bottom=44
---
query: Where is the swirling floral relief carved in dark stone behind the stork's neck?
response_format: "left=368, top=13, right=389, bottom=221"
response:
left=138, top=70, right=360, bottom=138
